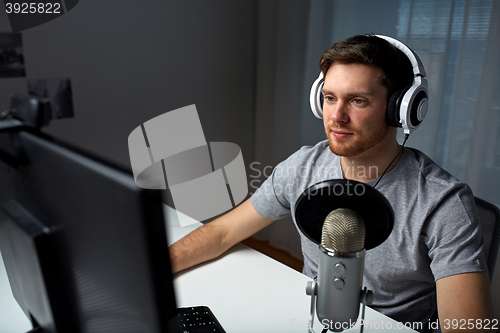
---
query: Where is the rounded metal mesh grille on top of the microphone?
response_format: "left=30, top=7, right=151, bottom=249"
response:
left=321, top=208, right=365, bottom=253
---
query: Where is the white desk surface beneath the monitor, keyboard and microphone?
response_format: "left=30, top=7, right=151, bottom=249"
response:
left=0, top=206, right=415, bottom=333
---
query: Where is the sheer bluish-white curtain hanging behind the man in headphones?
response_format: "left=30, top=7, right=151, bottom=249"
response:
left=296, top=0, right=500, bottom=206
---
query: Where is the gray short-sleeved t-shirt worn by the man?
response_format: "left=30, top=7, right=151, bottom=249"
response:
left=251, top=140, right=487, bottom=328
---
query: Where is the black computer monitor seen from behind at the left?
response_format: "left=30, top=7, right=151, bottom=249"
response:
left=0, top=128, right=177, bottom=333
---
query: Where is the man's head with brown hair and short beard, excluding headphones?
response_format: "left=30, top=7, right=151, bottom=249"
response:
left=320, top=36, right=413, bottom=157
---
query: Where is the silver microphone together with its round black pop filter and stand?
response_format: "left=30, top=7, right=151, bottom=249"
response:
left=295, top=179, right=394, bottom=333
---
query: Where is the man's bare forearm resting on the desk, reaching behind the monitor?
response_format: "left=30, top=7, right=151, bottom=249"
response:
left=169, top=199, right=273, bottom=273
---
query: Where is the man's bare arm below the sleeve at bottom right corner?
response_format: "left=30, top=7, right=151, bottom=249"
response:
left=436, top=272, right=494, bottom=332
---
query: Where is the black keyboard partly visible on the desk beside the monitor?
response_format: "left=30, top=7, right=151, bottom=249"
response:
left=177, top=306, right=226, bottom=333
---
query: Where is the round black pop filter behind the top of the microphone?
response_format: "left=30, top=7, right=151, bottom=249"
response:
left=295, top=179, right=394, bottom=250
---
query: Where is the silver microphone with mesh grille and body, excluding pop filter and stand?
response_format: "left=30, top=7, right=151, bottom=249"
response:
left=317, top=208, right=365, bottom=332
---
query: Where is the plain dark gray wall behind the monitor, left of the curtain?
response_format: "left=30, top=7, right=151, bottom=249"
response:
left=0, top=0, right=254, bottom=166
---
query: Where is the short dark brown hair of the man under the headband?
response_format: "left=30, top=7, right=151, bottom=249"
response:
left=319, top=35, right=413, bottom=96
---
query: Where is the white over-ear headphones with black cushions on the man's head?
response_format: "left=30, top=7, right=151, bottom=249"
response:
left=309, top=35, right=429, bottom=134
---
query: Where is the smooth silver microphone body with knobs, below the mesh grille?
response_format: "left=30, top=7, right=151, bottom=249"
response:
left=316, top=245, right=365, bottom=332
